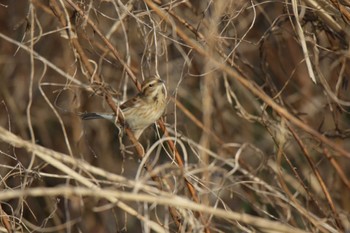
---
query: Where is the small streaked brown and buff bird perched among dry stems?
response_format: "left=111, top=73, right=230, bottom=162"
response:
left=80, top=76, right=167, bottom=140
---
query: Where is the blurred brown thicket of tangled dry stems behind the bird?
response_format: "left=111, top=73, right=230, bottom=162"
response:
left=0, top=0, right=350, bottom=232
